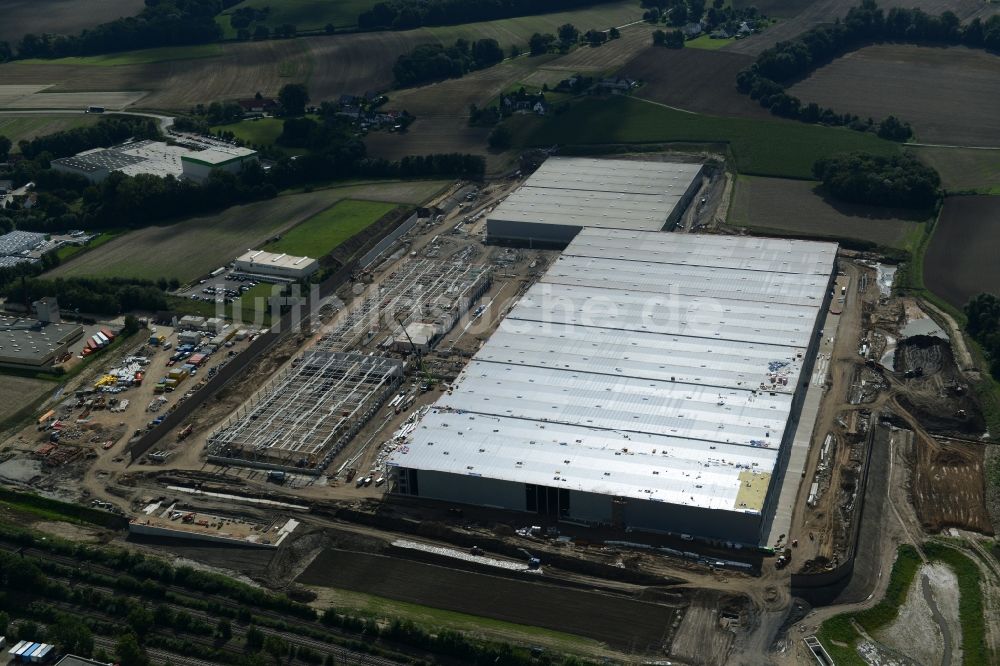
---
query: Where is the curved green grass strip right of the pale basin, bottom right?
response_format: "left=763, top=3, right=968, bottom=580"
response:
left=924, top=541, right=996, bottom=666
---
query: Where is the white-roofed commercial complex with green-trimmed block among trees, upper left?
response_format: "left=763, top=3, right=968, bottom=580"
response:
left=52, top=139, right=257, bottom=183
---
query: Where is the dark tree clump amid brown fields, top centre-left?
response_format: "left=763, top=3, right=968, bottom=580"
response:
left=392, top=39, right=504, bottom=88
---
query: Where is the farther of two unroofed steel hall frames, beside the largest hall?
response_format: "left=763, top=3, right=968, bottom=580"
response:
left=316, top=257, right=492, bottom=352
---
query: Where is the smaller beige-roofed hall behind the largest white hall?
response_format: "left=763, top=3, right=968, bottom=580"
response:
left=486, top=157, right=703, bottom=248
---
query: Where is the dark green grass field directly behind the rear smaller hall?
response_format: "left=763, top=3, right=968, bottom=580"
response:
left=512, top=97, right=900, bottom=179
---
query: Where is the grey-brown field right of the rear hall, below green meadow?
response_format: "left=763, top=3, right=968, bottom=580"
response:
left=729, top=176, right=925, bottom=249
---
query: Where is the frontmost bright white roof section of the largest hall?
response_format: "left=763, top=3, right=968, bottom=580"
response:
left=389, top=409, right=778, bottom=511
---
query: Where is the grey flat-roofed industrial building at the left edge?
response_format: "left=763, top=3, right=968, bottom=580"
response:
left=0, top=316, right=83, bottom=370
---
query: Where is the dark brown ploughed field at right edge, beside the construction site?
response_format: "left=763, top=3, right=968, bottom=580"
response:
left=924, top=196, right=1000, bottom=309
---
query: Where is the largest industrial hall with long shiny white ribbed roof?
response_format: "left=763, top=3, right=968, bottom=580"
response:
left=388, top=228, right=837, bottom=545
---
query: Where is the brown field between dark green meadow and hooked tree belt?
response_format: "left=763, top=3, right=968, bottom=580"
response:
left=620, top=46, right=774, bottom=118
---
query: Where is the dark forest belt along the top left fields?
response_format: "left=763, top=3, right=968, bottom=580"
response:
left=0, top=0, right=239, bottom=58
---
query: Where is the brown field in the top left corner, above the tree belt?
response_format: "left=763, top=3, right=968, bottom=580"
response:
left=0, top=0, right=144, bottom=44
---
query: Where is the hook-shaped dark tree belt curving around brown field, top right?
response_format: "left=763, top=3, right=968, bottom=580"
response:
left=736, top=0, right=1000, bottom=136
